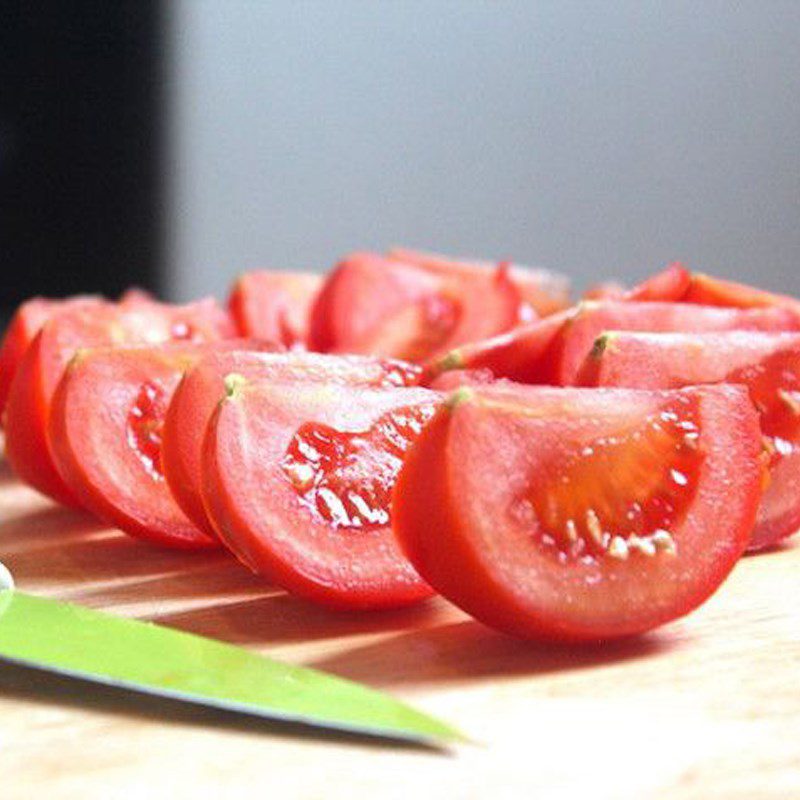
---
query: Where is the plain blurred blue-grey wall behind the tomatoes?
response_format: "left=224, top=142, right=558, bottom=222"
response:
left=170, top=0, right=800, bottom=298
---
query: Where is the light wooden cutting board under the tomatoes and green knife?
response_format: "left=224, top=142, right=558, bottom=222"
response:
left=0, top=456, right=800, bottom=800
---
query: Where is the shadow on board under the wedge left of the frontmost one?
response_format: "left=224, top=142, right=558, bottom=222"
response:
left=150, top=590, right=444, bottom=645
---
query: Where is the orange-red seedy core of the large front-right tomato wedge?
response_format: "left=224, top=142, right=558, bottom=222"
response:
left=513, top=402, right=703, bottom=562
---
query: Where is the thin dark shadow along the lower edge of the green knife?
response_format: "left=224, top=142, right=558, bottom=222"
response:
left=0, top=664, right=454, bottom=754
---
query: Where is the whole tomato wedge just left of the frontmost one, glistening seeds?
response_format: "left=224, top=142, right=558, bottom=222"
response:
left=203, top=378, right=440, bottom=609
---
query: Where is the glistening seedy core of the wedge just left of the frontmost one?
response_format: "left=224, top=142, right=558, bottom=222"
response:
left=281, top=404, right=435, bottom=530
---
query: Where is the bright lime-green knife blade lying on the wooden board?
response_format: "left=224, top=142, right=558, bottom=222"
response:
left=0, top=589, right=466, bottom=745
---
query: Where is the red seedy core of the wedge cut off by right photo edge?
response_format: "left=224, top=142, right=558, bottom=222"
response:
left=725, top=351, right=800, bottom=468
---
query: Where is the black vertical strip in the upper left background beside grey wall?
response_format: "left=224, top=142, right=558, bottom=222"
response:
left=0, top=0, right=163, bottom=314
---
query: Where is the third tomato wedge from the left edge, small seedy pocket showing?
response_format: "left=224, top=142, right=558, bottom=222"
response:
left=48, top=339, right=260, bottom=549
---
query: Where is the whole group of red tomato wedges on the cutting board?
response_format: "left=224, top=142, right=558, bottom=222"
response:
left=0, top=256, right=800, bottom=642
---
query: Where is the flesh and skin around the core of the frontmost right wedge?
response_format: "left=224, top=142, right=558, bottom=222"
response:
left=392, top=386, right=761, bottom=642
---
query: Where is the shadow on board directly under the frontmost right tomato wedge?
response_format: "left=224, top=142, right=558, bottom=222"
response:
left=307, top=619, right=680, bottom=687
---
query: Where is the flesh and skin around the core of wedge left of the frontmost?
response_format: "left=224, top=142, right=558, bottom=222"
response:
left=203, top=381, right=440, bottom=609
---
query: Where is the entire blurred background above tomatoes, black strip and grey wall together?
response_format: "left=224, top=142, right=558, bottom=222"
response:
left=0, top=0, right=800, bottom=311
